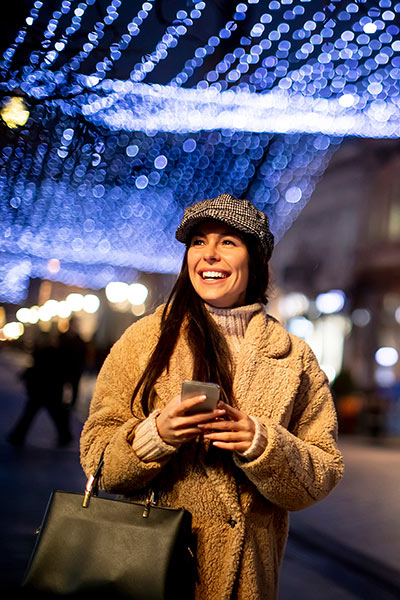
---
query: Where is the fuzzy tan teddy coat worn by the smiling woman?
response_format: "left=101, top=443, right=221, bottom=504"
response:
left=81, top=307, right=342, bottom=600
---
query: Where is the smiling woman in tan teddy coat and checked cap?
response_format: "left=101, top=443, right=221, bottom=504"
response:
left=81, top=194, right=342, bottom=600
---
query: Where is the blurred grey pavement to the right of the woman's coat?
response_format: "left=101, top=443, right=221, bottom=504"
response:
left=281, top=439, right=400, bottom=600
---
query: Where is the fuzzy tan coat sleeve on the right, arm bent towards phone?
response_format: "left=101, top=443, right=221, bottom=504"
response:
left=234, top=346, right=343, bottom=510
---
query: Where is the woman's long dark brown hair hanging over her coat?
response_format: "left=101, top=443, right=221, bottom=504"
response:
left=131, top=233, right=269, bottom=416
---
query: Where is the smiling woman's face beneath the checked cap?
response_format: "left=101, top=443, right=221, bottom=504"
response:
left=187, top=221, right=249, bottom=308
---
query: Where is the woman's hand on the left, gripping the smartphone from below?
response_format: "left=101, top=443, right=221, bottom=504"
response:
left=156, top=395, right=226, bottom=446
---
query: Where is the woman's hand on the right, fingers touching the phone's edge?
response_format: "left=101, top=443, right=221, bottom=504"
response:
left=198, top=402, right=256, bottom=452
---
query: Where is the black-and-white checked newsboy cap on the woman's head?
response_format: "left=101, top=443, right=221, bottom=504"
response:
left=175, top=194, right=274, bottom=260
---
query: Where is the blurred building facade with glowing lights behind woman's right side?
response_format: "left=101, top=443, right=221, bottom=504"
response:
left=273, top=139, right=400, bottom=433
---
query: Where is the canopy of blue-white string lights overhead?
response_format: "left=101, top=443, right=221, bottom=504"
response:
left=0, top=0, right=400, bottom=302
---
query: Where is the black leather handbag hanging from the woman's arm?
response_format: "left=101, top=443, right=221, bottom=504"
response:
left=22, top=457, right=196, bottom=600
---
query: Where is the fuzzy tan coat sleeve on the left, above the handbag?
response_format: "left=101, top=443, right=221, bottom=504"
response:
left=81, top=316, right=174, bottom=494
